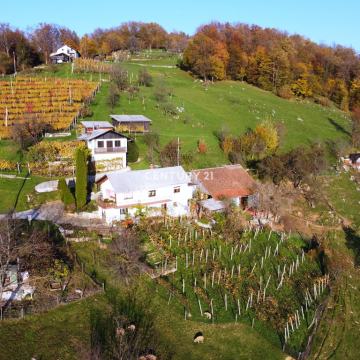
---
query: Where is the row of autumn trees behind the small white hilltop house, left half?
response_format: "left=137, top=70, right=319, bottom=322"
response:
left=0, top=22, right=189, bottom=74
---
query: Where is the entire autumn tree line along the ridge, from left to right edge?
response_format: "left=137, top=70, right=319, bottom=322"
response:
left=0, top=22, right=360, bottom=111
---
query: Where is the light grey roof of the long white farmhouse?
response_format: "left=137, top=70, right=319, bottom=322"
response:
left=100, top=166, right=190, bottom=193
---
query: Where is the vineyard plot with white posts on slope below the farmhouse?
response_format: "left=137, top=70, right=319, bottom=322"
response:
left=144, top=221, right=329, bottom=353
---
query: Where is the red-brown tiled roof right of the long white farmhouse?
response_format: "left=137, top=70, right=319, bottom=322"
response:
left=192, top=165, right=255, bottom=199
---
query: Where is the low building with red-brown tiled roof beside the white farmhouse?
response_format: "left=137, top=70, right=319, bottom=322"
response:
left=191, top=165, right=256, bottom=211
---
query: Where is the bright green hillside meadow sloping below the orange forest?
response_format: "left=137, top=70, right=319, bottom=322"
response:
left=86, top=60, right=350, bottom=167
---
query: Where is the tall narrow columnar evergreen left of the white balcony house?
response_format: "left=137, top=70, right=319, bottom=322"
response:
left=75, top=146, right=88, bottom=210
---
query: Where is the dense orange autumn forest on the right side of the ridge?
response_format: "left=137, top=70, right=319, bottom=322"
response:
left=182, top=23, right=360, bottom=111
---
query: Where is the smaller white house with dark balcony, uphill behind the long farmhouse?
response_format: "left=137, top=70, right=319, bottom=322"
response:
left=78, top=129, right=131, bottom=172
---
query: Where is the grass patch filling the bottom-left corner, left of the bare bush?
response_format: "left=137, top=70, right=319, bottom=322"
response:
left=0, top=296, right=105, bottom=360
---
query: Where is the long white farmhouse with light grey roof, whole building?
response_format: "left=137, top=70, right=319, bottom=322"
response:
left=97, top=166, right=194, bottom=223
